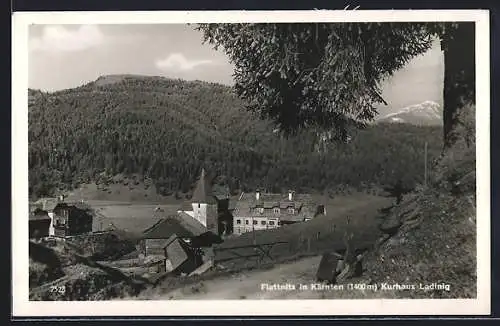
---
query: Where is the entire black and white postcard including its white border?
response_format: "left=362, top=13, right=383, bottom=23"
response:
left=12, top=10, right=490, bottom=316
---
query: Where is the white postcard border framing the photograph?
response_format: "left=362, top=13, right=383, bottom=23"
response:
left=12, top=10, right=491, bottom=317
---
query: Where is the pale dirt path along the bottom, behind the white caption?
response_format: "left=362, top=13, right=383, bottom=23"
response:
left=133, top=256, right=397, bottom=300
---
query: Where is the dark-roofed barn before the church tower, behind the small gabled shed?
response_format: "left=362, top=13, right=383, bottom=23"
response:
left=138, top=212, right=222, bottom=256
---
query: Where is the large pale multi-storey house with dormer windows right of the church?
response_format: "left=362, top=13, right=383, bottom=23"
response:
left=233, top=190, right=326, bottom=234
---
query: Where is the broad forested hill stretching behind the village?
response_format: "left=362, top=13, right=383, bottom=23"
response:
left=29, top=75, right=442, bottom=197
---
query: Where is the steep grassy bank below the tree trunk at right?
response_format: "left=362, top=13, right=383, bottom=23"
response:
left=354, top=108, right=478, bottom=298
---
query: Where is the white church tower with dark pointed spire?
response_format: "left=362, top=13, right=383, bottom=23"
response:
left=191, top=169, right=219, bottom=234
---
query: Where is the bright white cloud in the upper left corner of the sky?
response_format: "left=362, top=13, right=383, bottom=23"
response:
left=30, top=25, right=104, bottom=52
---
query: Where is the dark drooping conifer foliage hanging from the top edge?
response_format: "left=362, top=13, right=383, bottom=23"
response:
left=196, top=23, right=432, bottom=140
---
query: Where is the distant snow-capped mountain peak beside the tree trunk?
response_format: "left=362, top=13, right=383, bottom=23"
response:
left=377, top=101, right=443, bottom=125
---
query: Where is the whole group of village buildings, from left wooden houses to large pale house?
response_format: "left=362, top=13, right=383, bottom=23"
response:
left=29, top=170, right=326, bottom=274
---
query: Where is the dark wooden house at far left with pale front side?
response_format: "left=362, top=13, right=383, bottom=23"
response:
left=52, top=202, right=93, bottom=237
